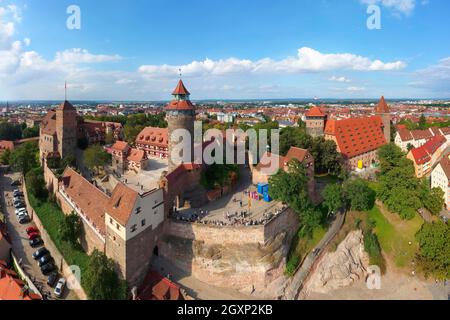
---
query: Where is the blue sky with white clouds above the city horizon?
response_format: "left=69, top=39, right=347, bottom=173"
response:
left=0, top=0, right=450, bottom=100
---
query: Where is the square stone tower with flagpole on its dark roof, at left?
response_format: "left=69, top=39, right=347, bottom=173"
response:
left=56, top=100, right=78, bottom=158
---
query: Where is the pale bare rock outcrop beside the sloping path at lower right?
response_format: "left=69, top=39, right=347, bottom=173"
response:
left=302, top=230, right=369, bottom=295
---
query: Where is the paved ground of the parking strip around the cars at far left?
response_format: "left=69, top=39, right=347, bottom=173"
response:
left=0, top=174, right=76, bottom=299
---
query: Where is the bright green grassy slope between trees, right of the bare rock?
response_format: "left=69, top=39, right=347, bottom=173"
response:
left=368, top=206, right=423, bottom=268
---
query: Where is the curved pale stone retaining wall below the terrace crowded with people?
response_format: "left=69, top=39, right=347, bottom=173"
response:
left=158, top=209, right=298, bottom=292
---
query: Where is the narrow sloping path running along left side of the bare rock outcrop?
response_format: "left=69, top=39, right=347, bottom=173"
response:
left=285, top=212, right=346, bottom=300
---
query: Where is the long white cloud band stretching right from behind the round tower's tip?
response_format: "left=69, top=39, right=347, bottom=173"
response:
left=139, top=47, right=406, bottom=77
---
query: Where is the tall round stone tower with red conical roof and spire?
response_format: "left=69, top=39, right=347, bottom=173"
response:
left=165, top=80, right=195, bottom=173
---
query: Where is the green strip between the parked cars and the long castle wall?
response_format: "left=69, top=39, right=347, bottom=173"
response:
left=28, top=193, right=89, bottom=279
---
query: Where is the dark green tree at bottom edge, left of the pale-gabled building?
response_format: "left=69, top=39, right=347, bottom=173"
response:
left=82, top=249, right=127, bottom=300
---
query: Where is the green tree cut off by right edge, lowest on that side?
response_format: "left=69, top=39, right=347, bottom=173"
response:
left=416, top=222, right=450, bottom=280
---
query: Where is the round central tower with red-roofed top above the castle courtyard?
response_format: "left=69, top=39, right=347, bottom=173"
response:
left=166, top=80, right=195, bottom=173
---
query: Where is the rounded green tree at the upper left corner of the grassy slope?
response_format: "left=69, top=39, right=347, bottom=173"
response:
left=343, top=179, right=375, bottom=211
